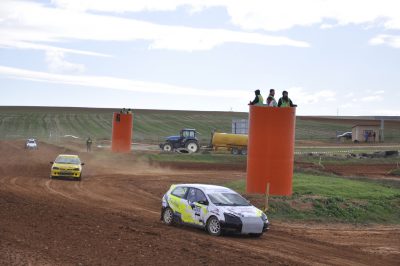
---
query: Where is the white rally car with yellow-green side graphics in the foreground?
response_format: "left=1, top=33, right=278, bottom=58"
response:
left=161, top=184, right=269, bottom=237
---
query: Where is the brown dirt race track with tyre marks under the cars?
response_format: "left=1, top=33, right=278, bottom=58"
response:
left=0, top=142, right=400, bottom=265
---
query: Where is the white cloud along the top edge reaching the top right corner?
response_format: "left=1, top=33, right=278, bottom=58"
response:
left=52, top=0, right=400, bottom=31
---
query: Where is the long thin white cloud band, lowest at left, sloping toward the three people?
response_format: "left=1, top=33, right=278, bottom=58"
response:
left=0, top=66, right=250, bottom=99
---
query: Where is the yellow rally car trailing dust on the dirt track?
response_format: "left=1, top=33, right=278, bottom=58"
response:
left=50, top=154, right=84, bottom=181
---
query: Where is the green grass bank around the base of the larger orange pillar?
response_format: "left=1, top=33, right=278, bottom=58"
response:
left=227, top=172, right=400, bottom=224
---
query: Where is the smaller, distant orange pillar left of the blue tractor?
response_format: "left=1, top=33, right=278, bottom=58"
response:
left=111, top=113, right=133, bottom=152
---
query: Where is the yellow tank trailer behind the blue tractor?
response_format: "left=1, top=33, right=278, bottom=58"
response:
left=211, top=132, right=248, bottom=155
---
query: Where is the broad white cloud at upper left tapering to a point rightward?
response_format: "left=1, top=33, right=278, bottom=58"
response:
left=0, top=0, right=309, bottom=54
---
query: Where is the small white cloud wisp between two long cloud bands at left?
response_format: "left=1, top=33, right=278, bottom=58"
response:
left=46, top=50, right=85, bottom=73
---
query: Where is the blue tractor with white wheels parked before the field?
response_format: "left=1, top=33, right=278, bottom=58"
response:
left=160, top=128, right=200, bottom=153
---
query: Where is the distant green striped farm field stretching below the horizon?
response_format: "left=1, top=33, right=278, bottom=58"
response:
left=0, top=107, right=400, bottom=145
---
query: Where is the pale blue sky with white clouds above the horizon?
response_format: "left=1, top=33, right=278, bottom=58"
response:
left=0, top=0, right=400, bottom=116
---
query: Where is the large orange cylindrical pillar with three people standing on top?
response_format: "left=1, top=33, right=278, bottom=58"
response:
left=246, top=105, right=296, bottom=196
